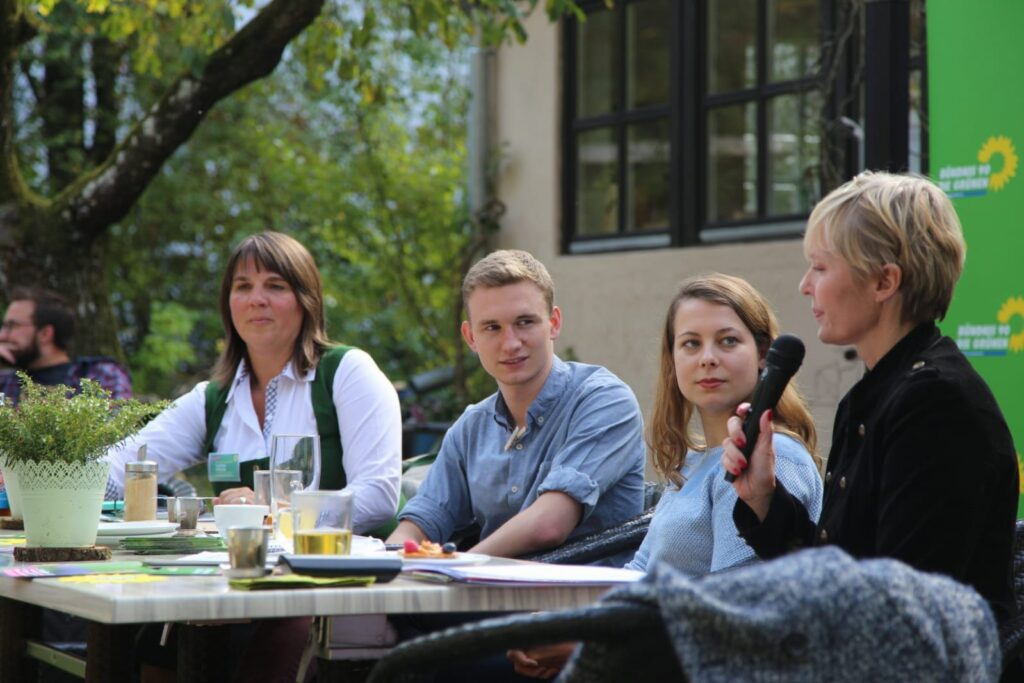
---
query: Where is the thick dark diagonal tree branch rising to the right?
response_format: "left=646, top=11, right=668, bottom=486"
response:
left=55, top=0, right=324, bottom=241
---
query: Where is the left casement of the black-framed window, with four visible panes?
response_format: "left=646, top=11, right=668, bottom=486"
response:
left=566, top=0, right=674, bottom=250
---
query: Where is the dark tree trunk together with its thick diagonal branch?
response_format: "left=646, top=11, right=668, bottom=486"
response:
left=0, top=0, right=324, bottom=356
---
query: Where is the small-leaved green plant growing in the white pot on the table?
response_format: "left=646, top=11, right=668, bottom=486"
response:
left=0, top=373, right=166, bottom=463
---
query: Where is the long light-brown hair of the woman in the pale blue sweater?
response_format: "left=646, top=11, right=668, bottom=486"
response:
left=647, top=273, right=817, bottom=486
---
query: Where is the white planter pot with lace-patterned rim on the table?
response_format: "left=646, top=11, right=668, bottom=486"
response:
left=5, top=460, right=111, bottom=548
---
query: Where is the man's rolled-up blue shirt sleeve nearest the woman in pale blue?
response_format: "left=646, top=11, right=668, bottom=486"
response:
left=538, top=382, right=644, bottom=521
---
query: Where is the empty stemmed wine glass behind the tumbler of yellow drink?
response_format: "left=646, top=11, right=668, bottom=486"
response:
left=270, top=434, right=321, bottom=542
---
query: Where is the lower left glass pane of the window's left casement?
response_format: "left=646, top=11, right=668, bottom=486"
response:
left=575, top=128, right=618, bottom=234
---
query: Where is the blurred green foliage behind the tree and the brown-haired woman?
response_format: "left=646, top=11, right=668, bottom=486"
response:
left=6, top=0, right=579, bottom=420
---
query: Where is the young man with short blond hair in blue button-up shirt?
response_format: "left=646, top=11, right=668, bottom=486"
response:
left=388, top=250, right=644, bottom=557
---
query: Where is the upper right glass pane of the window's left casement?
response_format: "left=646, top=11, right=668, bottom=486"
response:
left=626, top=0, right=672, bottom=109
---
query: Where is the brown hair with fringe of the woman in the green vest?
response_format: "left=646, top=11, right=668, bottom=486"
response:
left=213, top=231, right=331, bottom=386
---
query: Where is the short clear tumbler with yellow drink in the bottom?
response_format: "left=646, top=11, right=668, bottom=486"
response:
left=291, top=490, right=352, bottom=555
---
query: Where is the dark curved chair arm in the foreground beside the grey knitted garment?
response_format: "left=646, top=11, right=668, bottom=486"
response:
left=368, top=603, right=685, bottom=683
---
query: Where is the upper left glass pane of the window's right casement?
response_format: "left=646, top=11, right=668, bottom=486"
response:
left=708, top=0, right=758, bottom=92
